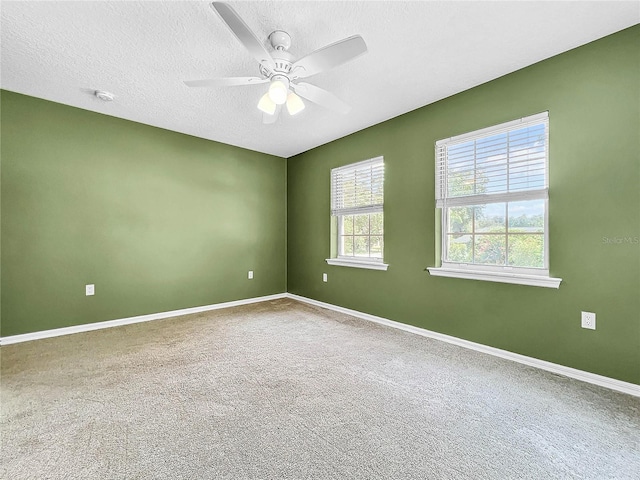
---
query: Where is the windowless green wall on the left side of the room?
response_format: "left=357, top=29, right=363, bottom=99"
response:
left=1, top=91, right=286, bottom=336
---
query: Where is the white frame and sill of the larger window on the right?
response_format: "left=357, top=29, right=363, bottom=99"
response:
left=427, top=112, right=562, bottom=288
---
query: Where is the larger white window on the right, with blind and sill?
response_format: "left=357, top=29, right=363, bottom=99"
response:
left=429, top=112, right=561, bottom=288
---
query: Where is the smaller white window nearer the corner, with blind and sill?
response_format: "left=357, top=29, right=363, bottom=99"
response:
left=327, top=157, right=388, bottom=270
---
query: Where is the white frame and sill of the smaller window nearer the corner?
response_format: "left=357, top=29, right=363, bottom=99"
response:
left=325, top=156, right=389, bottom=270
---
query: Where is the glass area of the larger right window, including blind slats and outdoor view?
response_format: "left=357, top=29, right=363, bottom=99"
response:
left=446, top=122, right=547, bottom=268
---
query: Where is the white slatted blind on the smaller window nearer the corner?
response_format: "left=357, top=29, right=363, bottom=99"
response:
left=331, top=157, right=384, bottom=216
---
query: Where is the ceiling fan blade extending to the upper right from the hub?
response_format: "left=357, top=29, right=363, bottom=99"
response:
left=291, top=35, right=367, bottom=78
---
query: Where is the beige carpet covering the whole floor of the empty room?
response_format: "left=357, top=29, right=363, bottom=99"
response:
left=0, top=299, right=640, bottom=480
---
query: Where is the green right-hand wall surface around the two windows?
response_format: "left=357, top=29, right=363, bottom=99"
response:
left=287, top=26, right=640, bottom=384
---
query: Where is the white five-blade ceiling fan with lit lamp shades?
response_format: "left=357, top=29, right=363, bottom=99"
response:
left=184, top=2, right=367, bottom=123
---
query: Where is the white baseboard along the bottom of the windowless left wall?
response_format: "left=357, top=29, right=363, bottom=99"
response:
left=0, top=293, right=286, bottom=345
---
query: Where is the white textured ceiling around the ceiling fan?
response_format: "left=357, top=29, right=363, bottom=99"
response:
left=1, top=0, right=640, bottom=157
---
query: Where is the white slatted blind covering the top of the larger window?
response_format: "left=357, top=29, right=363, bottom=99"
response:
left=436, top=112, right=549, bottom=208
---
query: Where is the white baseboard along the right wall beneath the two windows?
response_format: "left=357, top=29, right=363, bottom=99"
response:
left=286, top=293, right=640, bottom=397
